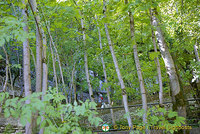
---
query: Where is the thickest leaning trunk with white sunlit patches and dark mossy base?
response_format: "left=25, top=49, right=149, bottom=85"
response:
left=151, top=9, right=186, bottom=133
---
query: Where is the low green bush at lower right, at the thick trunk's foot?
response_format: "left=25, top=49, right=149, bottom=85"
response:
left=128, top=106, right=185, bottom=134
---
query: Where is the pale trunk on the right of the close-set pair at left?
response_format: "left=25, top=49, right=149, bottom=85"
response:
left=39, top=30, right=48, bottom=134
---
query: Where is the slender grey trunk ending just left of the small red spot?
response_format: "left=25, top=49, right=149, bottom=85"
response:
left=80, top=13, right=94, bottom=101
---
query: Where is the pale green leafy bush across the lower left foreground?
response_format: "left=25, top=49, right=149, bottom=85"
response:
left=0, top=89, right=102, bottom=134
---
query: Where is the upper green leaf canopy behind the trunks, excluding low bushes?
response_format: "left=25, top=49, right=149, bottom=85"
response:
left=0, top=0, right=199, bottom=99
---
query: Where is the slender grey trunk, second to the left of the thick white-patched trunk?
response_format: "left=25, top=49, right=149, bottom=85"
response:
left=126, top=1, right=149, bottom=131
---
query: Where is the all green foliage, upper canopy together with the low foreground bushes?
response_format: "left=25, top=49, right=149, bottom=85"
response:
left=0, top=0, right=200, bottom=133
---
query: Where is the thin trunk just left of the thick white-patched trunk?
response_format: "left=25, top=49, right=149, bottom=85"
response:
left=150, top=11, right=163, bottom=106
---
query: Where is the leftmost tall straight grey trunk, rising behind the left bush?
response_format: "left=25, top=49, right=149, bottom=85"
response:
left=22, top=0, right=32, bottom=134
